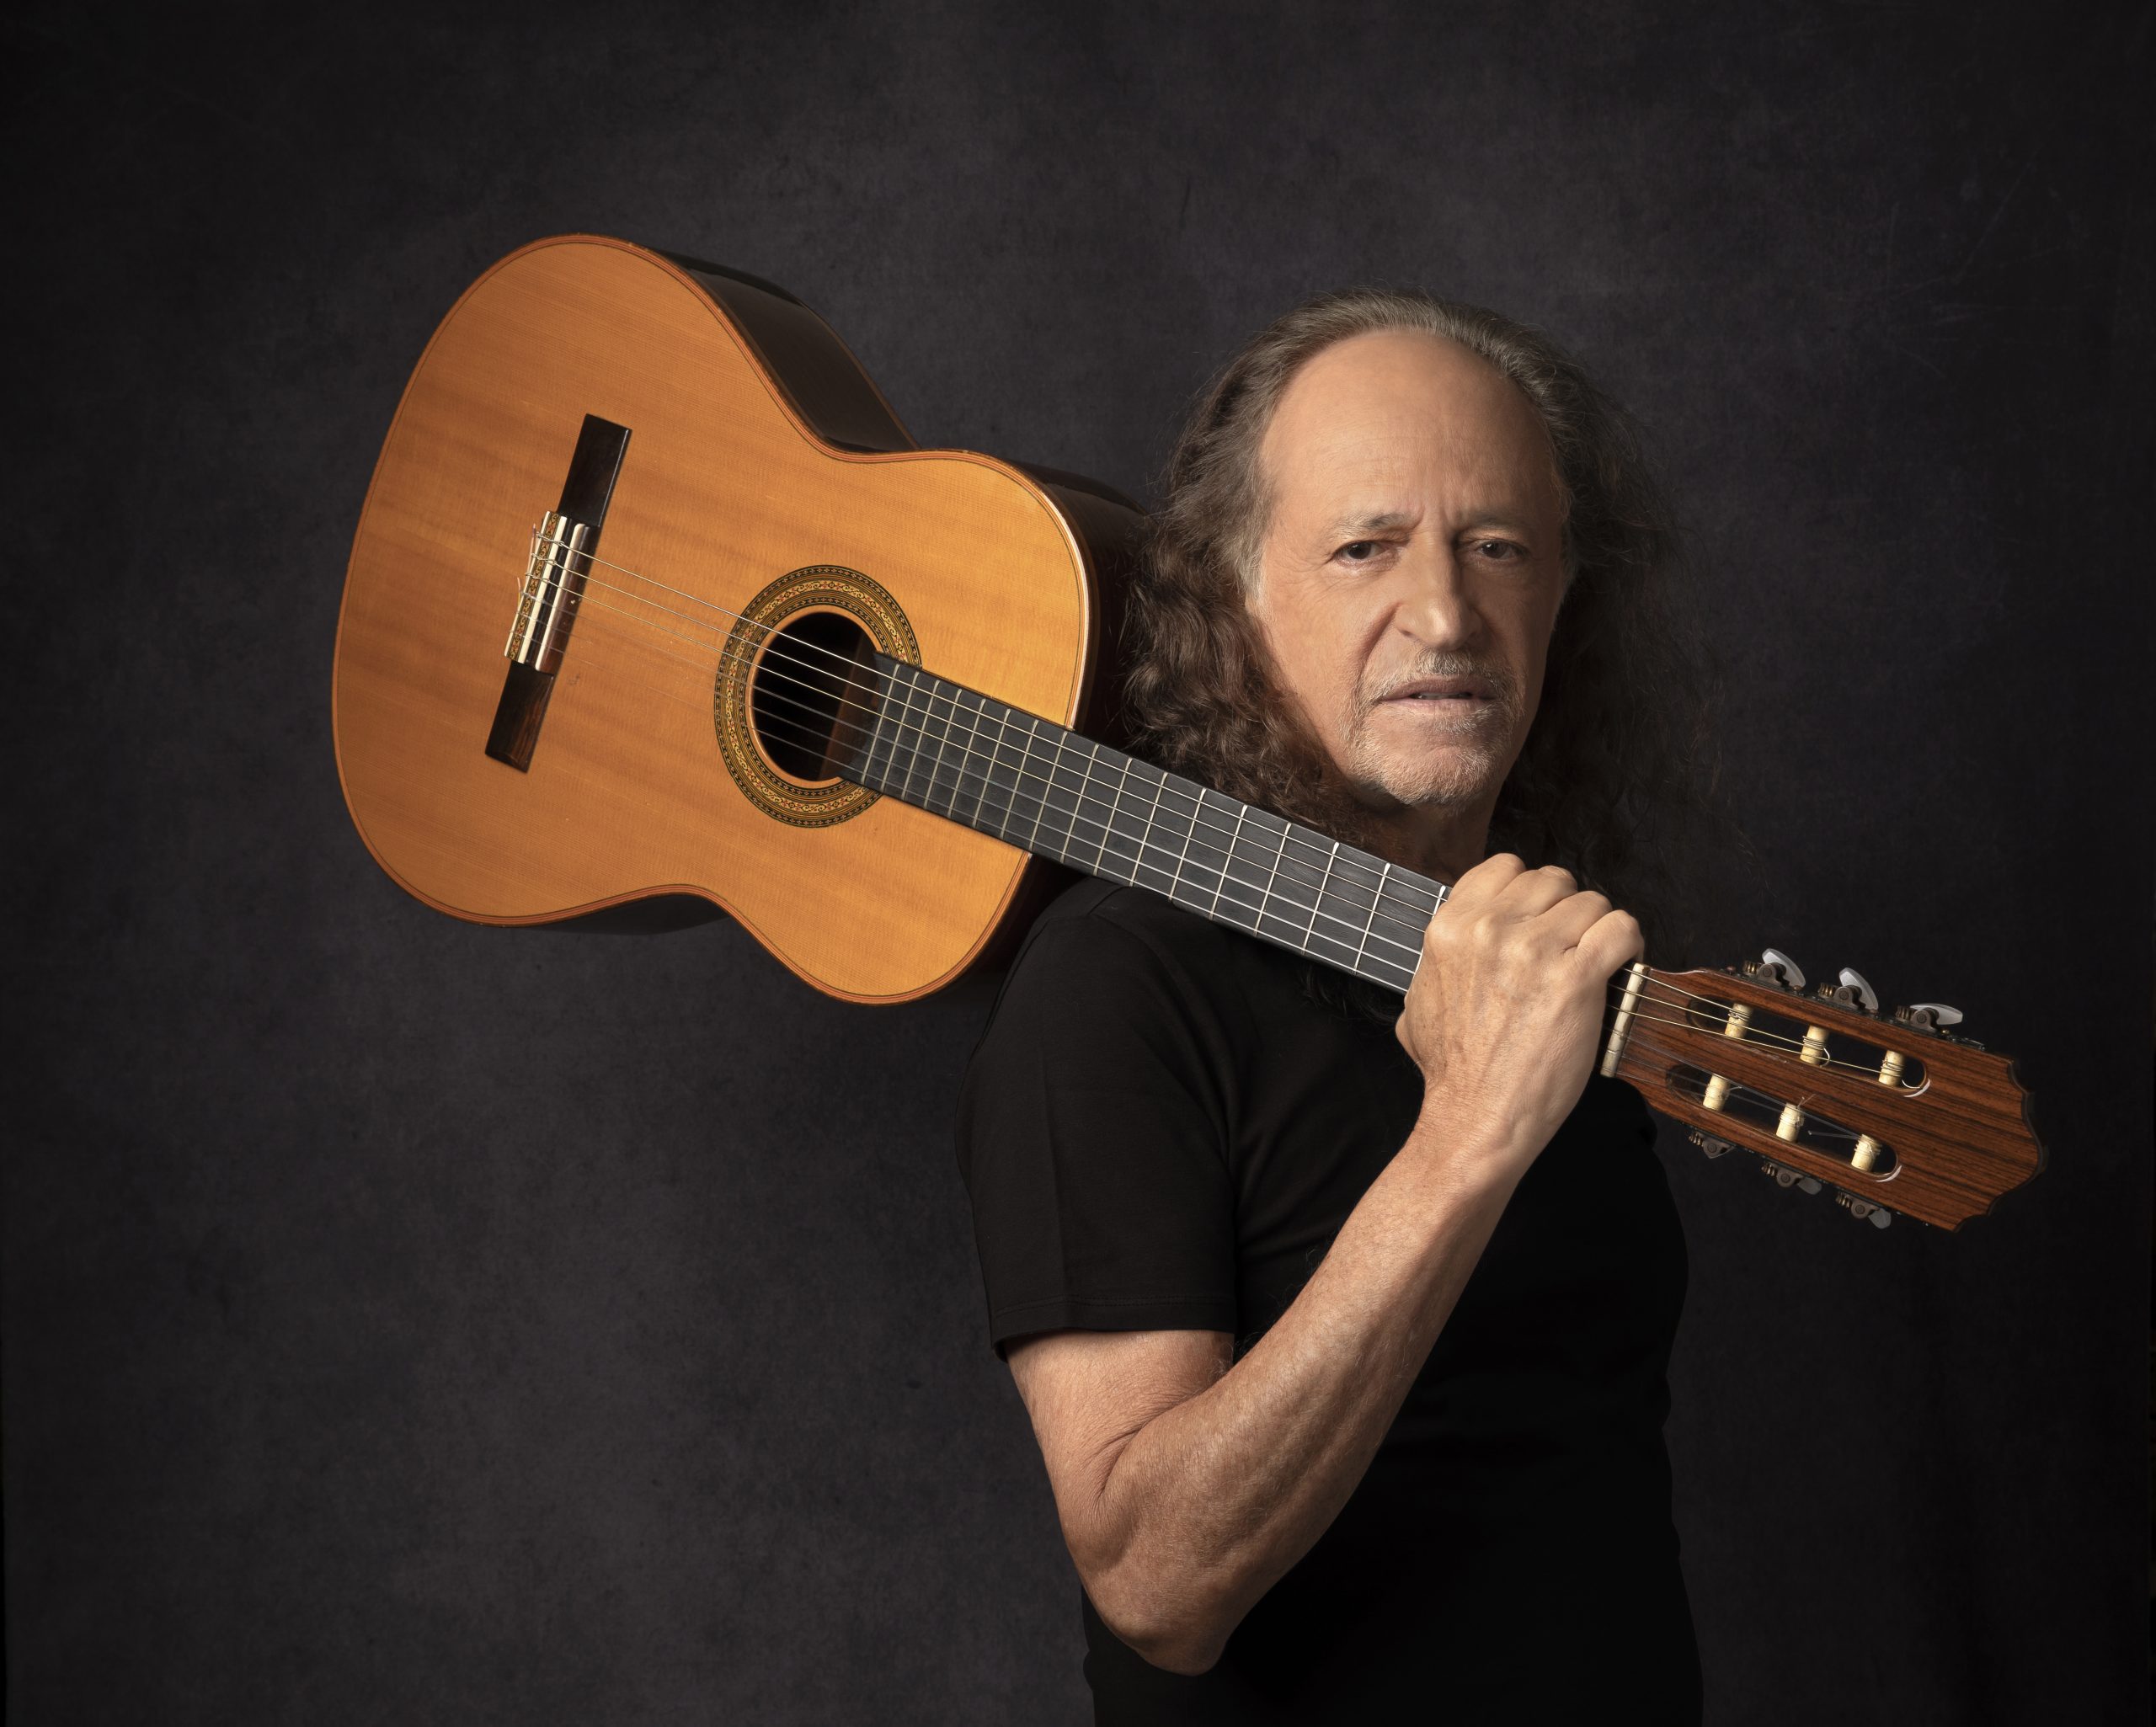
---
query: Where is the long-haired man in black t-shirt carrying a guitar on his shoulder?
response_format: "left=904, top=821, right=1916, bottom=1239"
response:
left=959, top=293, right=1699, bottom=1723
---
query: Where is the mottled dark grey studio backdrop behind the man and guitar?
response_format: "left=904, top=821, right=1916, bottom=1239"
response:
left=4, top=4, right=2156, bottom=1727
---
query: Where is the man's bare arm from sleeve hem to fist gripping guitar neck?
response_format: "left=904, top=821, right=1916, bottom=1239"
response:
left=1009, top=856, right=1639, bottom=1673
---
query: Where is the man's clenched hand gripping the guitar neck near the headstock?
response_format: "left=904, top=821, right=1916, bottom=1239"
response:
left=1397, top=851, right=1641, bottom=1180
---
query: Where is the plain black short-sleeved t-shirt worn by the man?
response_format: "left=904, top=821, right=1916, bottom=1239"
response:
left=959, top=882, right=1699, bottom=1727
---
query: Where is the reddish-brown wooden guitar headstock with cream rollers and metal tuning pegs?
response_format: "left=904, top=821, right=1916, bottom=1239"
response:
left=1602, top=949, right=2044, bottom=1229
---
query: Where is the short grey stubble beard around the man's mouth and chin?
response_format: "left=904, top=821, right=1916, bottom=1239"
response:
left=1345, top=653, right=1524, bottom=808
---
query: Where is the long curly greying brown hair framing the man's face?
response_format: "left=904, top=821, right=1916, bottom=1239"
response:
left=1123, top=289, right=1712, bottom=948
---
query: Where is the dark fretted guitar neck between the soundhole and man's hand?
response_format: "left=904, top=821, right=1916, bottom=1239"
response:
left=832, top=655, right=1447, bottom=994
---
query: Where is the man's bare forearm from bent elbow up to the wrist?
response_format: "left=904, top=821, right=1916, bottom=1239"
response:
left=1038, top=1126, right=1520, bottom=1671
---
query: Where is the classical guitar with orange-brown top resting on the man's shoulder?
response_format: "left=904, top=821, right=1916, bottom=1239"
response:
left=334, top=235, right=2044, bottom=1229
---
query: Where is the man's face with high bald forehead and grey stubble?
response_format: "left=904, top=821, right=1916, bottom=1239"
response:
left=1251, top=330, right=1566, bottom=817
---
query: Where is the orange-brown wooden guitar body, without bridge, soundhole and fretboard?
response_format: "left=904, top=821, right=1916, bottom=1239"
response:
left=334, top=237, right=1140, bottom=1000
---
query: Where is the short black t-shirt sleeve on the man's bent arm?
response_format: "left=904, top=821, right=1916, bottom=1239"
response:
left=958, top=910, right=1235, bottom=1354
